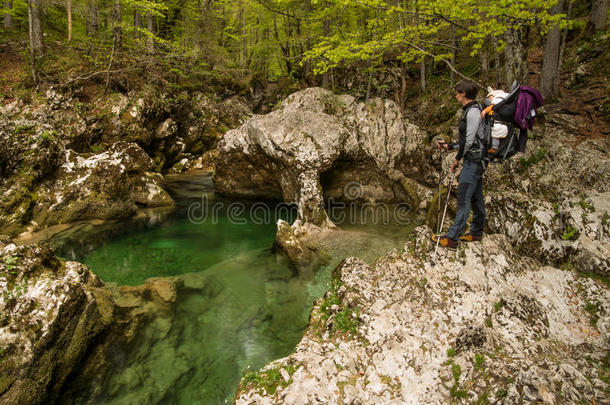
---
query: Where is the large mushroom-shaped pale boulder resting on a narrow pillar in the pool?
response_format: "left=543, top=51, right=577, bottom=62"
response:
left=214, top=88, right=424, bottom=228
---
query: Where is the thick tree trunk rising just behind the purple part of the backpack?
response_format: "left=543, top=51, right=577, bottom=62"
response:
left=540, top=0, right=565, bottom=99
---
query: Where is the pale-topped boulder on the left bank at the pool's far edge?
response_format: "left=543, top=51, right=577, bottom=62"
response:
left=0, top=142, right=173, bottom=234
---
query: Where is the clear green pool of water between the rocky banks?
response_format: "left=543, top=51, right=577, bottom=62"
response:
left=54, top=174, right=412, bottom=404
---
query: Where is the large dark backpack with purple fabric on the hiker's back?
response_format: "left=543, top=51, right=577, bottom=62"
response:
left=483, top=81, right=543, bottom=164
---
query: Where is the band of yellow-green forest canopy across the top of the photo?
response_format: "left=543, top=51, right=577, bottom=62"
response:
left=0, top=0, right=600, bottom=101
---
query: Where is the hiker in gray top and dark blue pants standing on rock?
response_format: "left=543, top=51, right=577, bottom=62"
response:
left=432, top=80, right=485, bottom=249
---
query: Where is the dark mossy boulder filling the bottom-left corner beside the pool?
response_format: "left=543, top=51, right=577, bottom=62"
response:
left=0, top=244, right=114, bottom=404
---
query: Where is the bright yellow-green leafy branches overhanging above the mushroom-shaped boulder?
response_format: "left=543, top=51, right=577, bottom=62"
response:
left=305, top=0, right=565, bottom=73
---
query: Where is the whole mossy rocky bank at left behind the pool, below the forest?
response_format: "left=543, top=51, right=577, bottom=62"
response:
left=0, top=89, right=251, bottom=236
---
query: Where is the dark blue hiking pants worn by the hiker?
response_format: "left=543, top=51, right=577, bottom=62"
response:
left=447, top=159, right=485, bottom=240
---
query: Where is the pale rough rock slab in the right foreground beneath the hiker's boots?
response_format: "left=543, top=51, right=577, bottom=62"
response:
left=236, top=228, right=610, bottom=404
